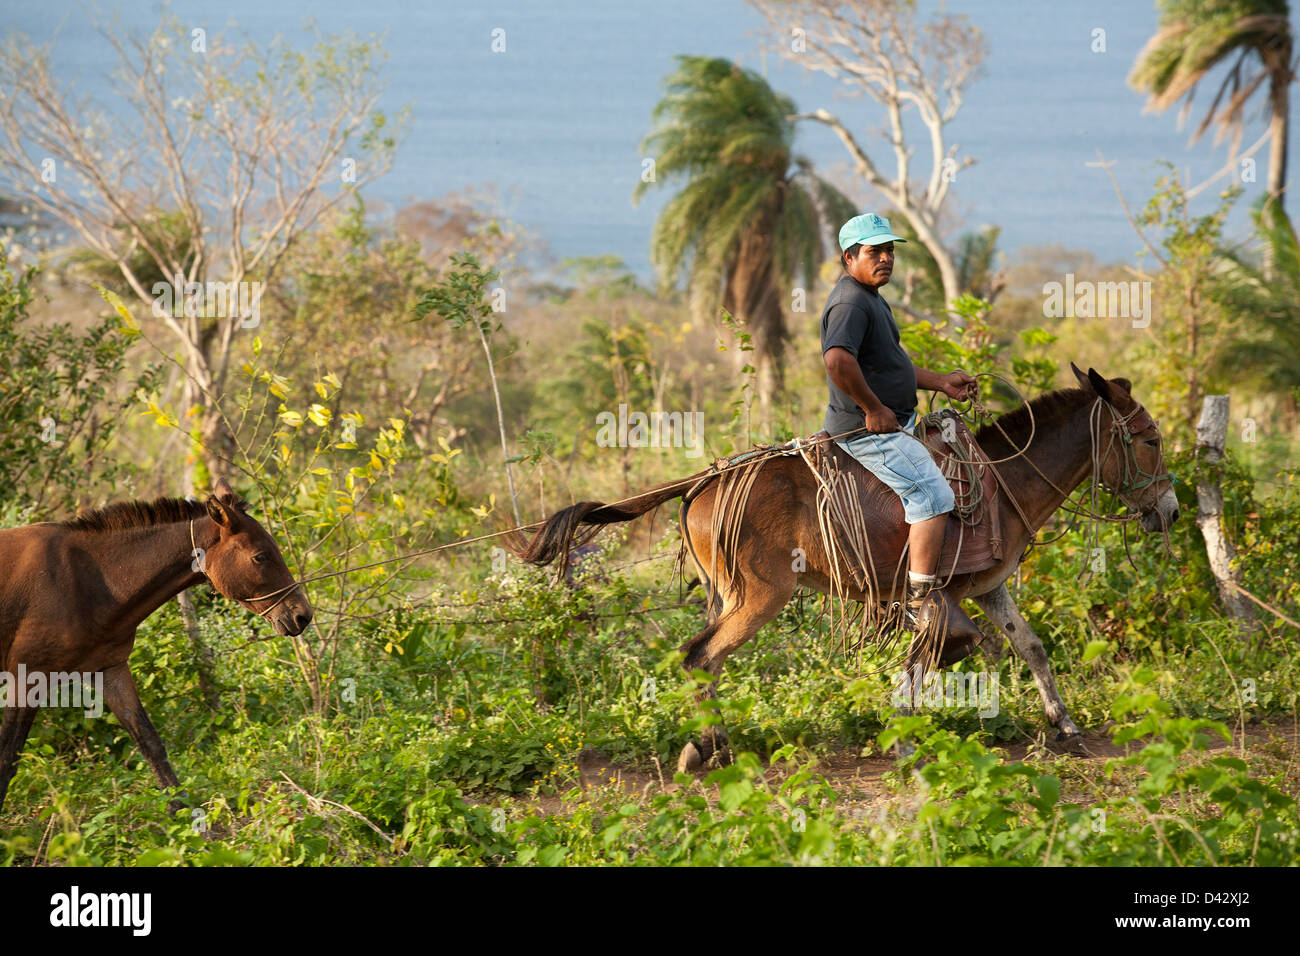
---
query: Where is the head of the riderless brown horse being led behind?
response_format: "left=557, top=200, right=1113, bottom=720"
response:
left=204, top=479, right=312, bottom=636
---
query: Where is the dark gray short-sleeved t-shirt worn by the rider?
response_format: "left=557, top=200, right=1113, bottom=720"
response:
left=822, top=273, right=917, bottom=434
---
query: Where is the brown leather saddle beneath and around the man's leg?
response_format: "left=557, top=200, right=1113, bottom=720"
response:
left=813, top=408, right=1002, bottom=579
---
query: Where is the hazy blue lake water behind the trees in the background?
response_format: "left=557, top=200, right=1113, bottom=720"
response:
left=5, top=0, right=1300, bottom=277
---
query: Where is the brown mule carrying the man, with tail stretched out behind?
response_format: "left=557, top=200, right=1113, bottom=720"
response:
left=511, top=364, right=1178, bottom=769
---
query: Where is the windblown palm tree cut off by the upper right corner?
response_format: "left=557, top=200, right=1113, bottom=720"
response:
left=1128, top=0, right=1294, bottom=208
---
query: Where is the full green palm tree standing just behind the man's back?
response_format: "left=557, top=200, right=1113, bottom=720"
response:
left=633, top=56, right=858, bottom=424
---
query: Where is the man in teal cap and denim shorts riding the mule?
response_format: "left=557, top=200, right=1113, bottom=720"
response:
left=822, top=213, right=975, bottom=630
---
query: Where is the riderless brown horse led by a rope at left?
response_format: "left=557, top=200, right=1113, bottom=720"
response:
left=0, top=481, right=312, bottom=808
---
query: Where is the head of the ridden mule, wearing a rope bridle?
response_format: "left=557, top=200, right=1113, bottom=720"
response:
left=1070, top=362, right=1178, bottom=531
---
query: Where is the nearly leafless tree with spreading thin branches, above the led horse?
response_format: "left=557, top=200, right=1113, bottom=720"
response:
left=0, top=14, right=397, bottom=494
